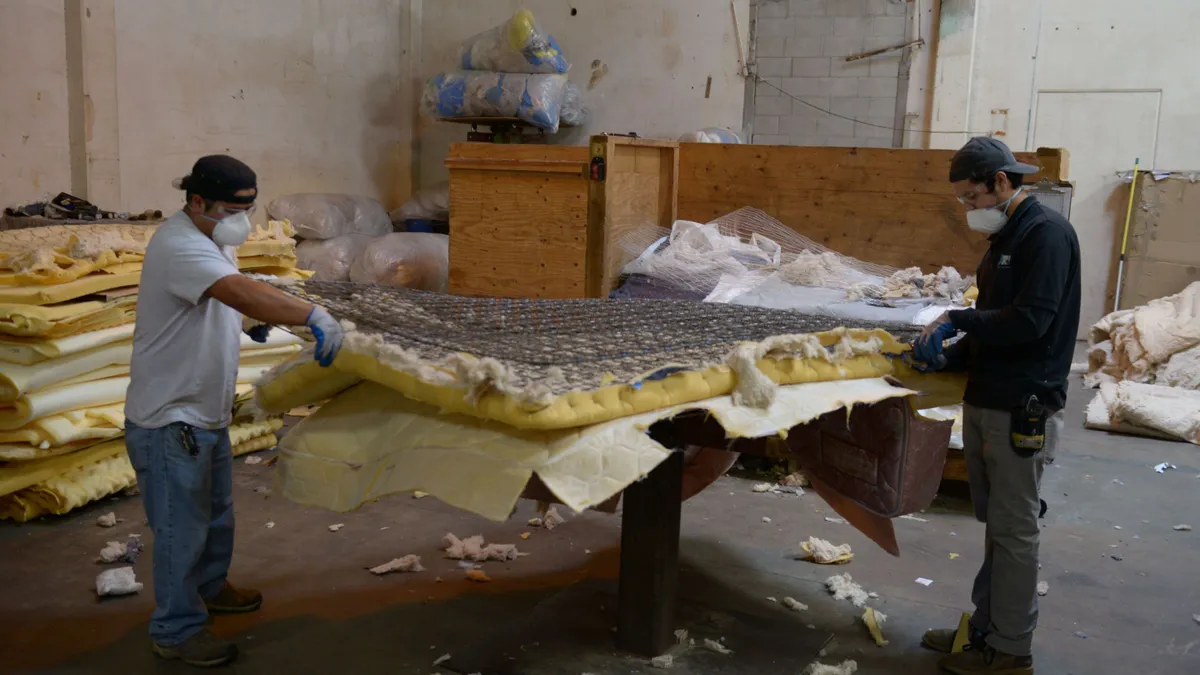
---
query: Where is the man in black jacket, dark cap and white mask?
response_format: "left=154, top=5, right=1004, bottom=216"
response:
left=913, top=137, right=1080, bottom=675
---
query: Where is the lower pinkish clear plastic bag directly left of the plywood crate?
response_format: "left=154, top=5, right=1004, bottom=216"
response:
left=350, top=232, right=450, bottom=293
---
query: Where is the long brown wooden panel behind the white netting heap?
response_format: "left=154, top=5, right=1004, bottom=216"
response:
left=679, top=143, right=1066, bottom=274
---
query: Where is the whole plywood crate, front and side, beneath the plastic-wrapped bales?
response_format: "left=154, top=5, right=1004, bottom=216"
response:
left=445, top=136, right=679, bottom=298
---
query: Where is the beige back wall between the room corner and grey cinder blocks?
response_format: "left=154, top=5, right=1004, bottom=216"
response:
left=418, top=0, right=749, bottom=185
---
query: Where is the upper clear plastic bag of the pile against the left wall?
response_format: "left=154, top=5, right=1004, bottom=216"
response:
left=266, top=193, right=391, bottom=239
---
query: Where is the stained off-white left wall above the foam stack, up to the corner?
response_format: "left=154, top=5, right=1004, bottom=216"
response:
left=0, top=0, right=414, bottom=210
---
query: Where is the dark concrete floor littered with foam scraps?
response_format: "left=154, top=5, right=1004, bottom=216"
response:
left=0, top=383, right=1200, bottom=675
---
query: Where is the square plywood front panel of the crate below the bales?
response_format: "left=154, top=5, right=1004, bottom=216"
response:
left=445, top=143, right=588, bottom=298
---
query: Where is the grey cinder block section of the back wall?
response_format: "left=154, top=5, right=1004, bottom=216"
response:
left=754, top=0, right=906, bottom=148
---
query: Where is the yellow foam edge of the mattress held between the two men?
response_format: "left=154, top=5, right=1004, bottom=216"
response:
left=259, top=330, right=902, bottom=429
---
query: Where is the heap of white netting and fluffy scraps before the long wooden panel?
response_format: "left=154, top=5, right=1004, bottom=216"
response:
left=619, top=208, right=973, bottom=322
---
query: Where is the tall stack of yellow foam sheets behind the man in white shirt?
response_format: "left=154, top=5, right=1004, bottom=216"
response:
left=0, top=221, right=305, bottom=521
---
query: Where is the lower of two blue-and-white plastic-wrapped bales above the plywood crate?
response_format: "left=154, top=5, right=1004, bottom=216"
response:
left=422, top=71, right=566, bottom=133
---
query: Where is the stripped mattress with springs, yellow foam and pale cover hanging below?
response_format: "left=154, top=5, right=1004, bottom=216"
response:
left=258, top=281, right=955, bottom=520
